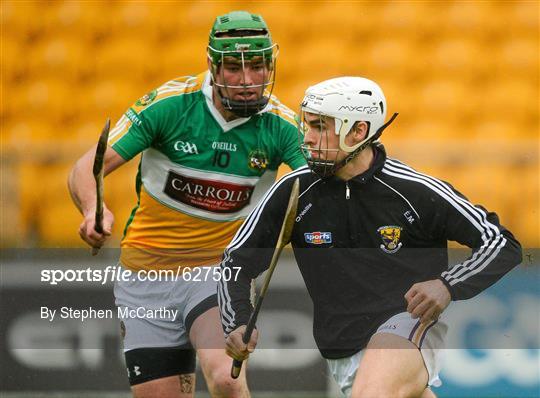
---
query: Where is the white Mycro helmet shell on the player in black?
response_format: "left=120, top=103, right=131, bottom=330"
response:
left=301, top=76, right=386, bottom=152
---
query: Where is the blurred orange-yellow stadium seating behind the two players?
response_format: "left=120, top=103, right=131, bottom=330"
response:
left=0, top=0, right=540, bottom=396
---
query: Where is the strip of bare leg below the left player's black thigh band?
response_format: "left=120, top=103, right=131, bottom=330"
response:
left=131, top=373, right=195, bottom=398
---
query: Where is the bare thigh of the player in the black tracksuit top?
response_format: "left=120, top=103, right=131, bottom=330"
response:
left=351, top=333, right=434, bottom=398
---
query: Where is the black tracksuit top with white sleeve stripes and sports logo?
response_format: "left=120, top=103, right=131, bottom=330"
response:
left=218, top=145, right=521, bottom=358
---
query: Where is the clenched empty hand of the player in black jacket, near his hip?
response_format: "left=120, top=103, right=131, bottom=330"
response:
left=405, top=279, right=452, bottom=324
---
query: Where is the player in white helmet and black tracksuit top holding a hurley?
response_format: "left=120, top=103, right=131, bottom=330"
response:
left=218, top=77, right=521, bottom=398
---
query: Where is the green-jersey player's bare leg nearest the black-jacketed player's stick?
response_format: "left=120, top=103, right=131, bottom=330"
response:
left=189, top=307, right=250, bottom=398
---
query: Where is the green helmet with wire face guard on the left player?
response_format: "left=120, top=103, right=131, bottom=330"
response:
left=207, top=11, right=279, bottom=117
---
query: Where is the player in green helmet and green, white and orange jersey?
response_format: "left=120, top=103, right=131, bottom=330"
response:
left=69, top=11, right=305, bottom=398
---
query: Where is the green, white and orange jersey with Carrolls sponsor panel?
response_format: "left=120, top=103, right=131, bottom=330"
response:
left=109, top=72, right=305, bottom=269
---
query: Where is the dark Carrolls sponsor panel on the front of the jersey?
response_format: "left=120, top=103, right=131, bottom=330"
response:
left=163, top=171, right=254, bottom=213
